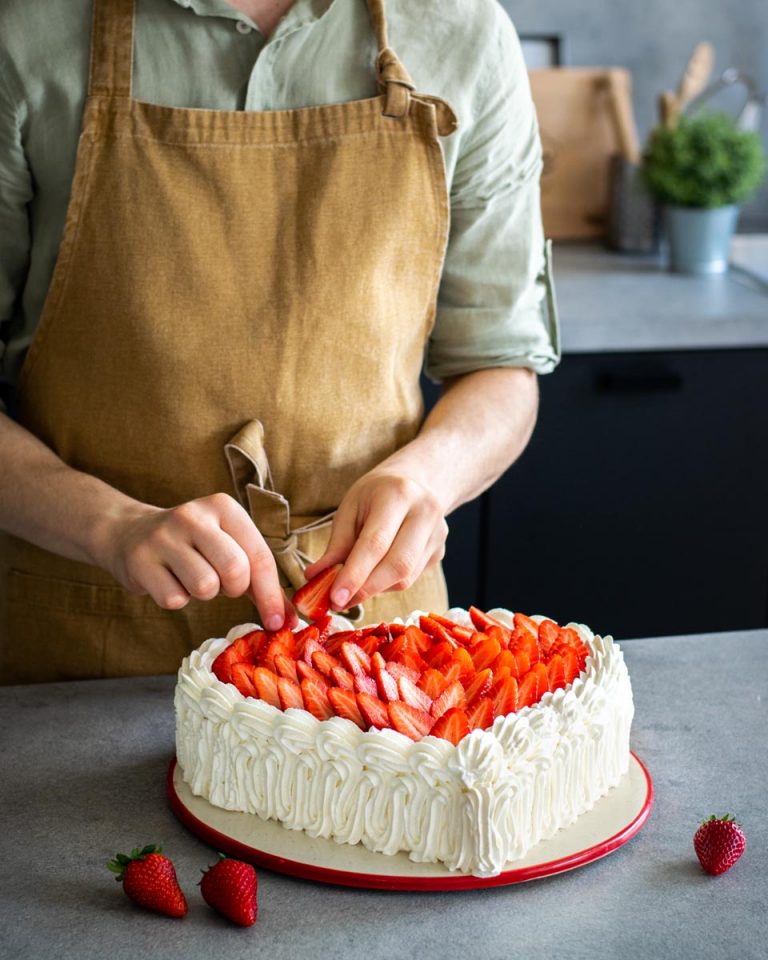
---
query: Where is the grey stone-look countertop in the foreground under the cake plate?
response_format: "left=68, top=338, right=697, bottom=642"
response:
left=0, top=630, right=768, bottom=960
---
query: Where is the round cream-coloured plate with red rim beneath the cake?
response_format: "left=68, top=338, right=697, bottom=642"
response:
left=166, top=753, right=653, bottom=891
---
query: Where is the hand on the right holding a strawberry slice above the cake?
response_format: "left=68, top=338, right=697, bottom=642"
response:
left=305, top=467, right=448, bottom=610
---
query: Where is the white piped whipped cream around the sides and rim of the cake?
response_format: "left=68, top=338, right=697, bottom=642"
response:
left=175, top=609, right=634, bottom=877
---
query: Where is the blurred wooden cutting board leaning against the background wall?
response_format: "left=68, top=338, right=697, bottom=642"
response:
left=529, top=67, right=634, bottom=239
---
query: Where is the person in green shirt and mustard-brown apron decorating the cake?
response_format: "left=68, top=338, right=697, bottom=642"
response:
left=0, top=0, right=558, bottom=683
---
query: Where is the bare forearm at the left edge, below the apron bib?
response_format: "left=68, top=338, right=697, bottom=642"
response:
left=0, top=414, right=140, bottom=563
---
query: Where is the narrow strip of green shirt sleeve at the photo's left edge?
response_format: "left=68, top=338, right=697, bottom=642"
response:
left=0, top=52, right=32, bottom=410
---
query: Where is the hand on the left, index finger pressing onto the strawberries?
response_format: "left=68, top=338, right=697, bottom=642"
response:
left=91, top=493, right=297, bottom=630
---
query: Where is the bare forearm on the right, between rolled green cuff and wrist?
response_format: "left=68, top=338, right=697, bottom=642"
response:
left=379, top=367, right=538, bottom=515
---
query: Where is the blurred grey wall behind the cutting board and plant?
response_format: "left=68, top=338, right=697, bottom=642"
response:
left=500, top=0, right=768, bottom=230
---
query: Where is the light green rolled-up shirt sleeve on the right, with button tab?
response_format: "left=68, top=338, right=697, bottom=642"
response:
left=426, top=8, right=560, bottom=381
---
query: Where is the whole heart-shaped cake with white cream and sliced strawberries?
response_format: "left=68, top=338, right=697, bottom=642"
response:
left=175, top=608, right=633, bottom=877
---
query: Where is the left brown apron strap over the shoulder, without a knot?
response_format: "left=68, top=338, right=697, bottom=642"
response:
left=88, top=0, right=134, bottom=99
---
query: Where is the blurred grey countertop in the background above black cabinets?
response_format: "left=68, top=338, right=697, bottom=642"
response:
left=553, top=244, right=768, bottom=354
